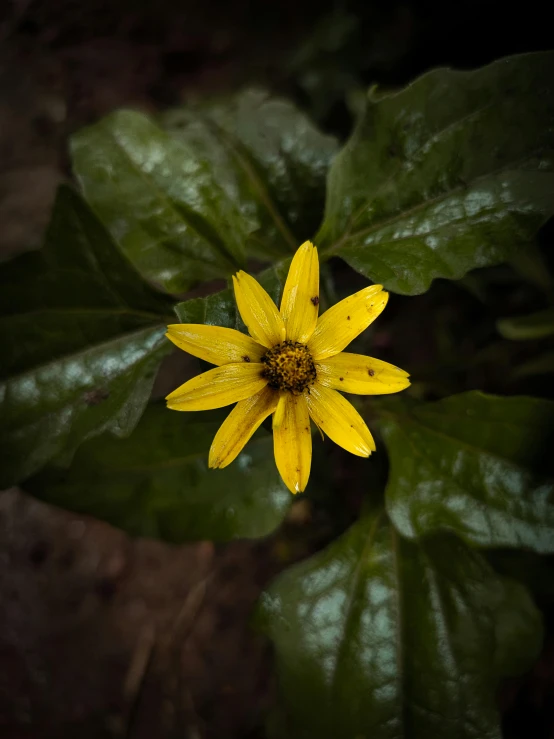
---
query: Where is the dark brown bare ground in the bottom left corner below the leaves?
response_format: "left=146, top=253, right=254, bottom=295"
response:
left=0, top=491, right=275, bottom=739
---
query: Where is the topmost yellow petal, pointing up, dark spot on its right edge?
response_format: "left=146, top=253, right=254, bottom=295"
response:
left=281, top=241, right=319, bottom=344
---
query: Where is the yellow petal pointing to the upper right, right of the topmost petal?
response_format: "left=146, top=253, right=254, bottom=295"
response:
left=308, top=285, right=389, bottom=359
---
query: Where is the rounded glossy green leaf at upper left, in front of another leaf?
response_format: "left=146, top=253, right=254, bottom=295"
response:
left=71, top=110, right=248, bottom=292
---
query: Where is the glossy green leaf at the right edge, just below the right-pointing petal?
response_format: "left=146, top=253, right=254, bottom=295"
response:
left=382, top=392, right=554, bottom=552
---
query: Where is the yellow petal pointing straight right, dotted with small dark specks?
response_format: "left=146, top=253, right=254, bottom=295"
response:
left=316, top=352, right=410, bottom=395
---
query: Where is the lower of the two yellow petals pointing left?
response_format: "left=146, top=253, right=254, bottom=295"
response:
left=166, top=362, right=267, bottom=411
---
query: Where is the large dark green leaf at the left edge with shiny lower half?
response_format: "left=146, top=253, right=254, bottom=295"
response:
left=0, top=187, right=171, bottom=487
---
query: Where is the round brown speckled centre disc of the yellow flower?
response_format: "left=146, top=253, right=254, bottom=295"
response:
left=261, top=341, right=317, bottom=395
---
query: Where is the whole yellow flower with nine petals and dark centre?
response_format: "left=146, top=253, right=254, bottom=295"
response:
left=166, top=241, right=410, bottom=493
